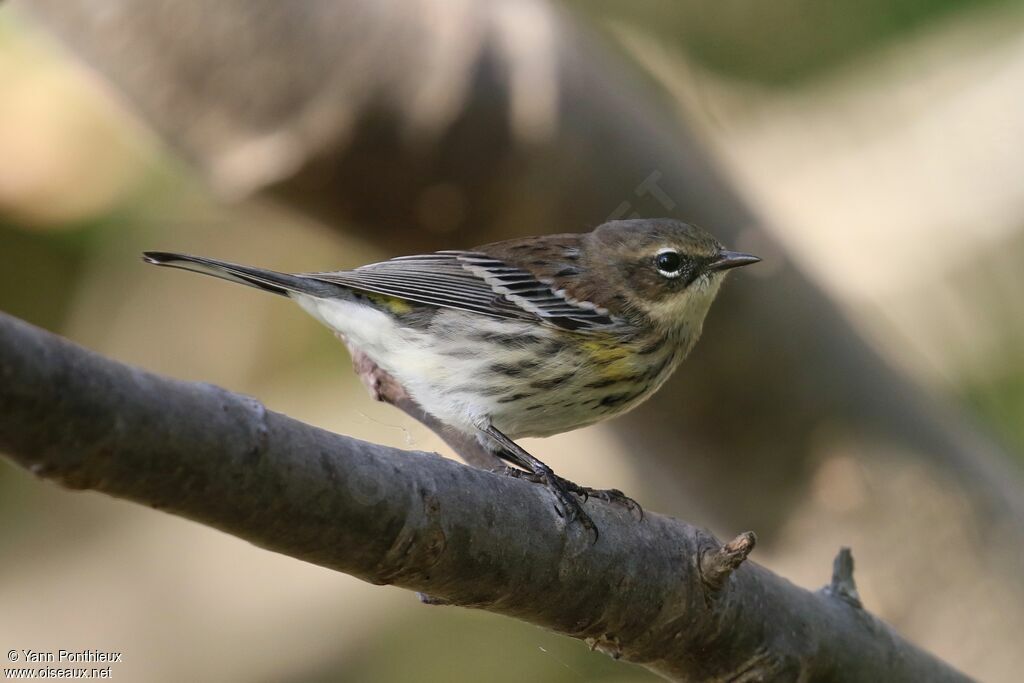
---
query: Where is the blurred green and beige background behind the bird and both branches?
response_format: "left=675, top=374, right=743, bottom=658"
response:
left=0, top=0, right=1024, bottom=681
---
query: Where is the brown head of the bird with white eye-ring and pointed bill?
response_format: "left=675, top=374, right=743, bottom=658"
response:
left=582, top=218, right=761, bottom=331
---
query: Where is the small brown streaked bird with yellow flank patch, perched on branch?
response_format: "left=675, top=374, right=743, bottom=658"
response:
left=144, top=218, right=760, bottom=539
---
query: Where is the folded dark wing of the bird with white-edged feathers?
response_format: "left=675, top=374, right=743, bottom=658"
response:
left=303, top=251, right=621, bottom=332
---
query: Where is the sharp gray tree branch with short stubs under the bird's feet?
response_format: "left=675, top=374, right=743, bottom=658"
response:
left=0, top=314, right=968, bottom=681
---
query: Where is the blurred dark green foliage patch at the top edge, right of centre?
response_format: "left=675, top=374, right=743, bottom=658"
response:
left=567, top=0, right=1008, bottom=85
